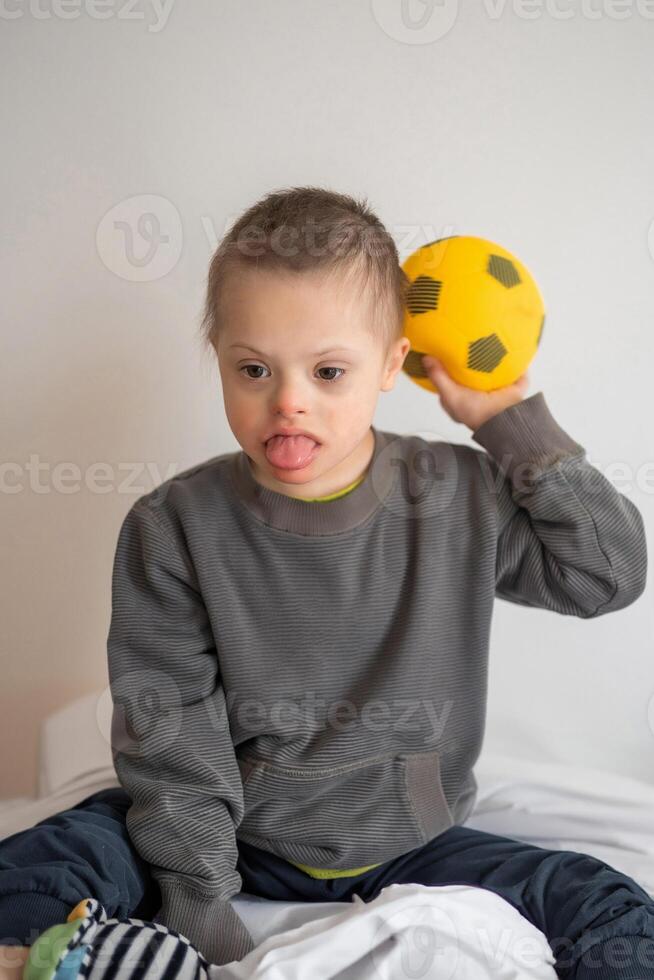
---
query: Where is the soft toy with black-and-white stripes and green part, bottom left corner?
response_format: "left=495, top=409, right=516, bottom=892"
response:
left=22, top=898, right=210, bottom=980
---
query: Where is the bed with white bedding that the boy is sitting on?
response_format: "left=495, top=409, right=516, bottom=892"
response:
left=0, top=692, right=654, bottom=980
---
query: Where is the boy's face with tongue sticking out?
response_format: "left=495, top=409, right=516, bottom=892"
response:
left=216, top=269, right=410, bottom=498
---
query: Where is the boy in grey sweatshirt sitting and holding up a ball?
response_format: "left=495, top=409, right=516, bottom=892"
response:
left=0, top=188, right=654, bottom=980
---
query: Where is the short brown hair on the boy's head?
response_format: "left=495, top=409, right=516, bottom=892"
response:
left=201, top=187, right=409, bottom=352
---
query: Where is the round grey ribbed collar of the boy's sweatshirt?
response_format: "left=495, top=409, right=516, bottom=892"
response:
left=229, top=425, right=396, bottom=536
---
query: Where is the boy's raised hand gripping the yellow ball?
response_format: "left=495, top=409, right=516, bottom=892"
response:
left=422, top=354, right=529, bottom=432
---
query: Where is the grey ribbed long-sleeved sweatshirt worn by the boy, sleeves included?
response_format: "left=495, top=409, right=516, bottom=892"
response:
left=107, top=392, right=647, bottom=963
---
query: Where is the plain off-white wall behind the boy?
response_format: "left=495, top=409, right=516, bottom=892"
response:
left=0, top=0, right=654, bottom=796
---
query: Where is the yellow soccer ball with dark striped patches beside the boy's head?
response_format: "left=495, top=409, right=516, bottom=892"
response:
left=402, top=235, right=545, bottom=391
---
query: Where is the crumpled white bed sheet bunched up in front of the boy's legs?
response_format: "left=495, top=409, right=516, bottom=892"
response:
left=209, top=885, right=556, bottom=980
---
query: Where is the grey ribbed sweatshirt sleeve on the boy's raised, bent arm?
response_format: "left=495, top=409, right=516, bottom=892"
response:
left=472, top=392, right=647, bottom=619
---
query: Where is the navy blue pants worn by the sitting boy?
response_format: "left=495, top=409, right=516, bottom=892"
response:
left=0, top=788, right=654, bottom=980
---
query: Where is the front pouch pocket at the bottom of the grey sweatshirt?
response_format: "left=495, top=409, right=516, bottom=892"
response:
left=237, top=750, right=454, bottom=869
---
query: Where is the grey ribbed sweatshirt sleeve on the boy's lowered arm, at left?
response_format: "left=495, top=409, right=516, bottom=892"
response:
left=107, top=500, right=254, bottom=964
